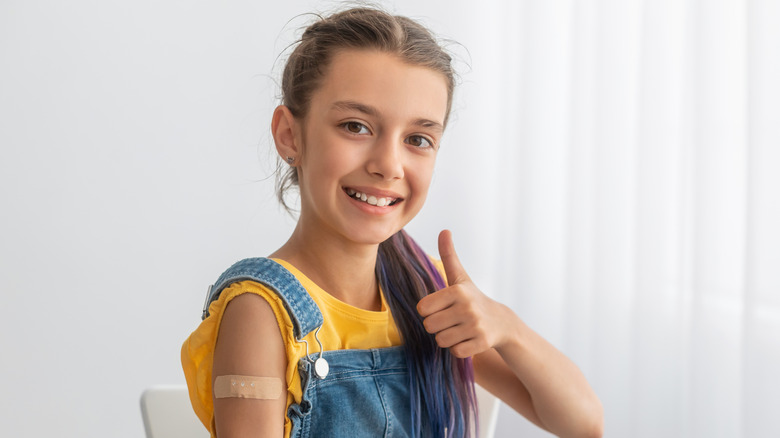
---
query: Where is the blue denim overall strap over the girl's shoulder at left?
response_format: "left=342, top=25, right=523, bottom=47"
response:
left=202, top=257, right=323, bottom=341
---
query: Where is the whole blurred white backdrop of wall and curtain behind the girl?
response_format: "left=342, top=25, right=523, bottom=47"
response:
left=0, top=0, right=780, bottom=438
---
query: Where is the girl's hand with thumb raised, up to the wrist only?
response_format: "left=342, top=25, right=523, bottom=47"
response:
left=417, top=230, right=514, bottom=358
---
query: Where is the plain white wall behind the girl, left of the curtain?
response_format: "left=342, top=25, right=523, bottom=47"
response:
left=0, top=0, right=517, bottom=437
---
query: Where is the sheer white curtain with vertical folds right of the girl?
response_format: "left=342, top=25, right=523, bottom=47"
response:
left=456, top=0, right=780, bottom=437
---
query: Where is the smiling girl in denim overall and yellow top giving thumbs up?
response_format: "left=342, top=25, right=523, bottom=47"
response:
left=182, top=8, right=602, bottom=438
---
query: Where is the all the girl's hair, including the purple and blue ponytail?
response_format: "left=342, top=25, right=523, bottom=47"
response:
left=277, top=8, right=479, bottom=437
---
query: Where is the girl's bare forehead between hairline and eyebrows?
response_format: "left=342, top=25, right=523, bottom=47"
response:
left=310, top=50, right=448, bottom=124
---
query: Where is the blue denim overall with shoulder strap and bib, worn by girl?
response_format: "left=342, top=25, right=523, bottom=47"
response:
left=203, top=258, right=418, bottom=438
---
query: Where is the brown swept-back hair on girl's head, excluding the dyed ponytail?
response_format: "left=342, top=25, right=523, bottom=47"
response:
left=276, top=8, right=455, bottom=211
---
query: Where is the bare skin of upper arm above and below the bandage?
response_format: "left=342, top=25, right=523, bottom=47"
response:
left=212, top=293, right=287, bottom=438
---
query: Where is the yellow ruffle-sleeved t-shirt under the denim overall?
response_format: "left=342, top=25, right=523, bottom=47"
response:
left=181, top=259, right=401, bottom=437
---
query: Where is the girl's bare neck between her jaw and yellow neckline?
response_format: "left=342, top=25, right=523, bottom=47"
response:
left=271, top=221, right=382, bottom=311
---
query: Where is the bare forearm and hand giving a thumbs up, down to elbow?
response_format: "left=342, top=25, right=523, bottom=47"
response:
left=417, top=231, right=603, bottom=438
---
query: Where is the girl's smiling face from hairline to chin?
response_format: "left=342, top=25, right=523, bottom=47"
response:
left=299, top=50, right=448, bottom=248
